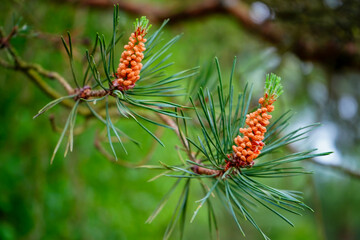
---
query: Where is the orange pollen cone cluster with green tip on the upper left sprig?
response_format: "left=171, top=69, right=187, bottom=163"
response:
left=113, top=17, right=151, bottom=91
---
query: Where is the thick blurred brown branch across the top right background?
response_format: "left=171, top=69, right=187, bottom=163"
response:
left=67, top=0, right=360, bottom=71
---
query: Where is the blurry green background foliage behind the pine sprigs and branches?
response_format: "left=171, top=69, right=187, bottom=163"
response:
left=0, top=0, right=360, bottom=239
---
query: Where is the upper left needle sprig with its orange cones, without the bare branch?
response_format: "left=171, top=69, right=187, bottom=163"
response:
left=32, top=5, right=197, bottom=160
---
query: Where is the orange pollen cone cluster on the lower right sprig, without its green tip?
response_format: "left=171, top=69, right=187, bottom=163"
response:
left=225, top=93, right=275, bottom=170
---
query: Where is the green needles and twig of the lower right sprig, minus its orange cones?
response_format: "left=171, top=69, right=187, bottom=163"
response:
left=151, top=59, right=330, bottom=239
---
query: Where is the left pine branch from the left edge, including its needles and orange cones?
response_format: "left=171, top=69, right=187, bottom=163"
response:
left=0, top=13, right=197, bottom=162
